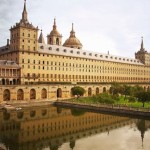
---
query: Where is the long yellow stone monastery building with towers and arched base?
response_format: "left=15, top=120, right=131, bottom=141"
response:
left=0, top=1, right=150, bottom=101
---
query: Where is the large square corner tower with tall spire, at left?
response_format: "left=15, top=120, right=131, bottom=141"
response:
left=10, top=0, right=38, bottom=51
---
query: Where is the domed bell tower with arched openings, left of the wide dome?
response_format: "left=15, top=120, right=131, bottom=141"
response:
left=47, top=18, right=62, bottom=45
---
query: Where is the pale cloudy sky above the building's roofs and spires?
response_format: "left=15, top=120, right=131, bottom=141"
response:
left=0, top=0, right=150, bottom=58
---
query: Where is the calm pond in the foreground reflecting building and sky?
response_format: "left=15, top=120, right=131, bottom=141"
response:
left=0, top=105, right=150, bottom=150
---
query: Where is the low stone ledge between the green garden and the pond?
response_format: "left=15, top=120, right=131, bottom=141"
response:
left=54, top=101, right=150, bottom=118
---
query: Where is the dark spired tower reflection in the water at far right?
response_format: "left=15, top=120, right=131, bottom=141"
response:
left=137, top=119, right=147, bottom=148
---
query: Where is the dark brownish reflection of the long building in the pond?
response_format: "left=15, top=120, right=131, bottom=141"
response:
left=0, top=106, right=149, bottom=150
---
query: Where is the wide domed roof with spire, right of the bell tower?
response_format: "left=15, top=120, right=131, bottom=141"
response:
left=63, top=24, right=82, bottom=49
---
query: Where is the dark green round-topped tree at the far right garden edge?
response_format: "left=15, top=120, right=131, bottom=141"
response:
left=136, top=91, right=150, bottom=107
